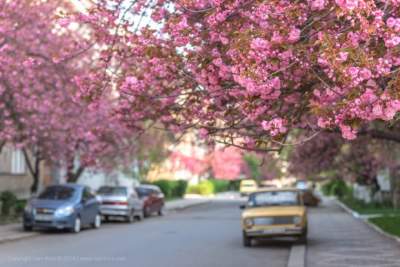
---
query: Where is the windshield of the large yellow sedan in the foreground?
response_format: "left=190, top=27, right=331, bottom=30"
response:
left=249, top=191, right=300, bottom=206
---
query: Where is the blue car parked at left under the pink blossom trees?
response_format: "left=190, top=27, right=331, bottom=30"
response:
left=23, top=184, right=101, bottom=233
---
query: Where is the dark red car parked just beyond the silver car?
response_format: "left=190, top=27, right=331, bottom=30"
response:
left=136, top=185, right=164, bottom=217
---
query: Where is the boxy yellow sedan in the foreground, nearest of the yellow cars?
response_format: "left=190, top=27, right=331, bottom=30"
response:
left=241, top=188, right=307, bottom=247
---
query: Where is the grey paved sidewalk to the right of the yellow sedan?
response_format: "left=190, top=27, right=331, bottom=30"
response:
left=306, top=199, right=400, bottom=267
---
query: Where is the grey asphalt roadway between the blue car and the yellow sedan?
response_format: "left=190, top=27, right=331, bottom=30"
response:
left=0, top=201, right=292, bottom=267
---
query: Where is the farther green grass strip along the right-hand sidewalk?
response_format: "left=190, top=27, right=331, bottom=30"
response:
left=340, top=197, right=400, bottom=216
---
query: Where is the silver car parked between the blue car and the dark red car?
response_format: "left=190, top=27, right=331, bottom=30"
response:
left=97, top=186, right=143, bottom=222
